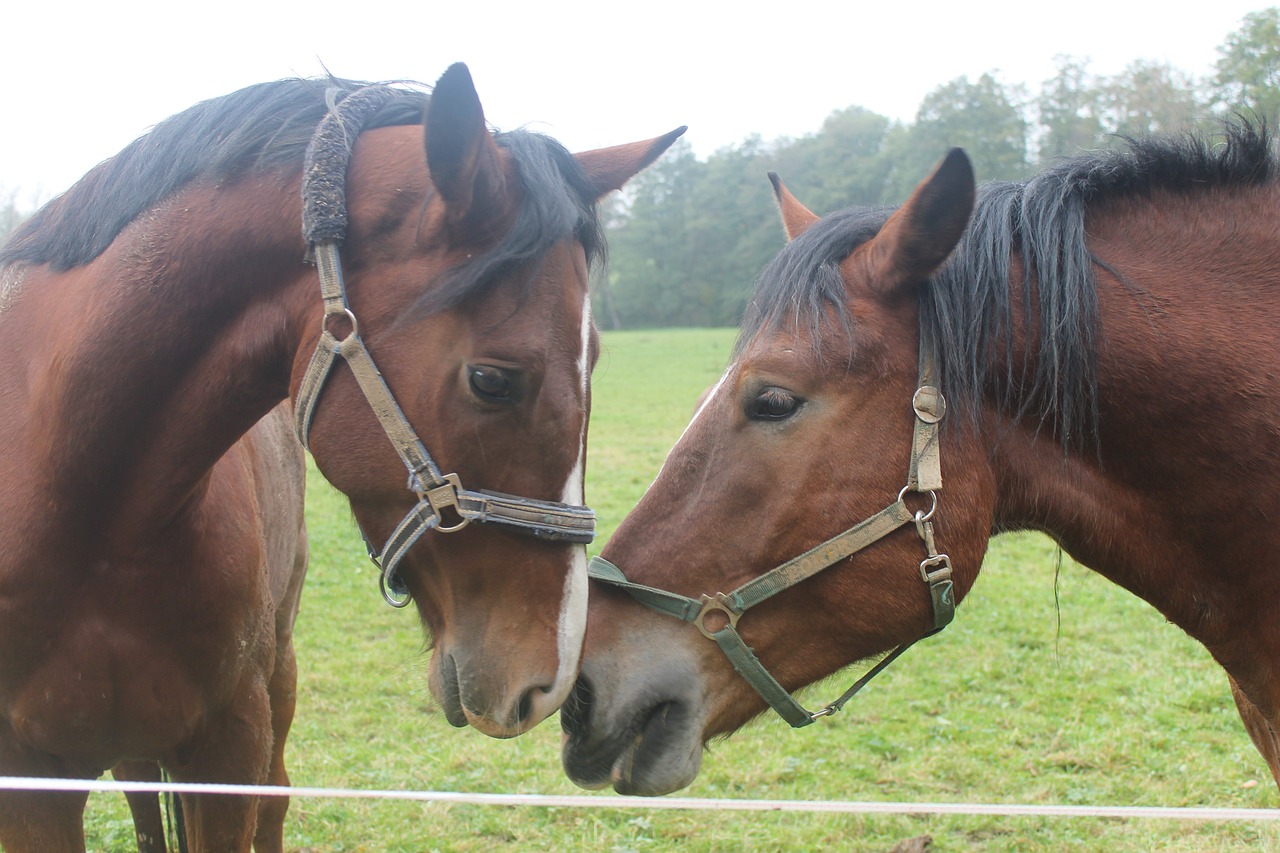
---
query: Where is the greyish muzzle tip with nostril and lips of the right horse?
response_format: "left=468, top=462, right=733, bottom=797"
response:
left=561, top=681, right=703, bottom=797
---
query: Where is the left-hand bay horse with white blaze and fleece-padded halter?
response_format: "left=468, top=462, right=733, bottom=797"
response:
left=0, top=64, right=682, bottom=853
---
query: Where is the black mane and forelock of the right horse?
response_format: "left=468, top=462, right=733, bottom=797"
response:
left=739, top=120, right=1276, bottom=444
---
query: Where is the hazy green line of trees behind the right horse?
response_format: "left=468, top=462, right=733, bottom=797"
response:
left=595, top=8, right=1280, bottom=328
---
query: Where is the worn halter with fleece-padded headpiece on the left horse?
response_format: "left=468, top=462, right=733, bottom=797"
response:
left=294, top=86, right=595, bottom=607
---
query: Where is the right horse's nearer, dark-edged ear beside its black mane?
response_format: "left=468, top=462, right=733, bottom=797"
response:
left=872, top=149, right=974, bottom=293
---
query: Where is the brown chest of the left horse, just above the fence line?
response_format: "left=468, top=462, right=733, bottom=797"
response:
left=0, top=550, right=274, bottom=768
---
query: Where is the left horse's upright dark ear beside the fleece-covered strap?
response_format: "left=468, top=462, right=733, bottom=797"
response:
left=424, top=63, right=507, bottom=223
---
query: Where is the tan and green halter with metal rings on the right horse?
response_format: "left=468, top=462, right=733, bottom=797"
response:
left=588, top=329, right=955, bottom=727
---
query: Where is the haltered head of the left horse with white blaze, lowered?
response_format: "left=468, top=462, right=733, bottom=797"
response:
left=293, top=65, right=684, bottom=736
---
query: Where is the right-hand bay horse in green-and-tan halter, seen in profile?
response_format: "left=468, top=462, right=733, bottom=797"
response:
left=561, top=122, right=1280, bottom=794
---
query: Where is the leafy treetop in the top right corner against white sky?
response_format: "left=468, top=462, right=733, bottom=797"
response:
left=1213, top=6, right=1280, bottom=122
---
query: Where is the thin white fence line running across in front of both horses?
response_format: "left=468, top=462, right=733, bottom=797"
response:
left=0, top=776, right=1280, bottom=821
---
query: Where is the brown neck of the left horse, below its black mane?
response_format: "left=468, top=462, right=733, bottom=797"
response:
left=0, top=177, right=315, bottom=540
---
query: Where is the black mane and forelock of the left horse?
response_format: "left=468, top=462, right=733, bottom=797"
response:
left=0, top=77, right=604, bottom=311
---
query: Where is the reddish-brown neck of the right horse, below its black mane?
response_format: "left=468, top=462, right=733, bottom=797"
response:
left=987, top=188, right=1280, bottom=637
